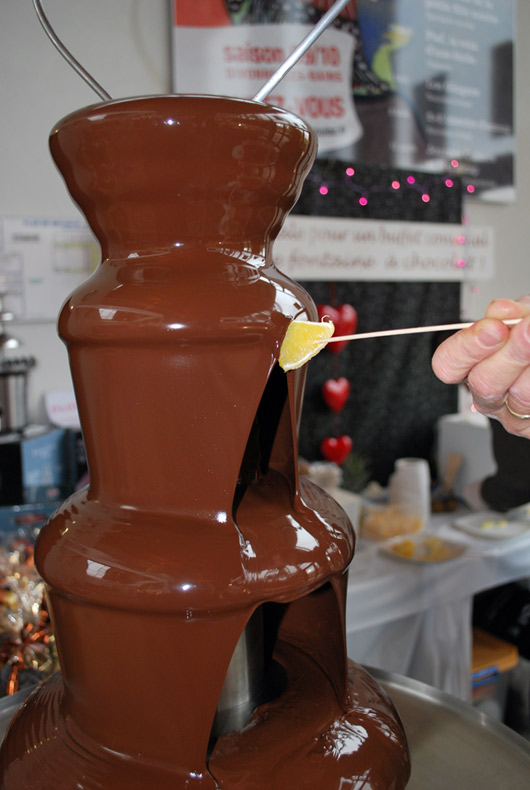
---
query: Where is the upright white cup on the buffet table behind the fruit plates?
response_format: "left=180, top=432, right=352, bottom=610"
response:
left=389, top=458, right=431, bottom=528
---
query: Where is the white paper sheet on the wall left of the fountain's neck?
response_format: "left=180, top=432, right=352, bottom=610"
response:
left=0, top=217, right=99, bottom=321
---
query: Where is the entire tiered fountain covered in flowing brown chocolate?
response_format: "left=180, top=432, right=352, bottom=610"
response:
left=0, top=96, right=409, bottom=790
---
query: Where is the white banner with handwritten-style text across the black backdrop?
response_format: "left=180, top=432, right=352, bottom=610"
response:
left=273, top=215, right=494, bottom=282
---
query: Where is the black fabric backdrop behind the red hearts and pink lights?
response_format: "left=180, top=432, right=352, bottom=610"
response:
left=293, top=160, right=462, bottom=485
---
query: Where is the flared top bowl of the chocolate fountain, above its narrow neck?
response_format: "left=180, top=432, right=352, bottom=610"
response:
left=50, top=95, right=316, bottom=257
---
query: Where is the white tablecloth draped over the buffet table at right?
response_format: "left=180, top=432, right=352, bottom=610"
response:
left=346, top=515, right=530, bottom=700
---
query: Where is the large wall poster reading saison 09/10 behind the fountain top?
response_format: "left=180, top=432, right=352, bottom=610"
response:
left=172, top=0, right=515, bottom=202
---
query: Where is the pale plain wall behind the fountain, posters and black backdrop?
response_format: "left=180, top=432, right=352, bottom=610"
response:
left=0, top=0, right=530, bottom=421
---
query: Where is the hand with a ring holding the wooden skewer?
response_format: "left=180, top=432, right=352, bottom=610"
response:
left=432, top=296, right=530, bottom=439
